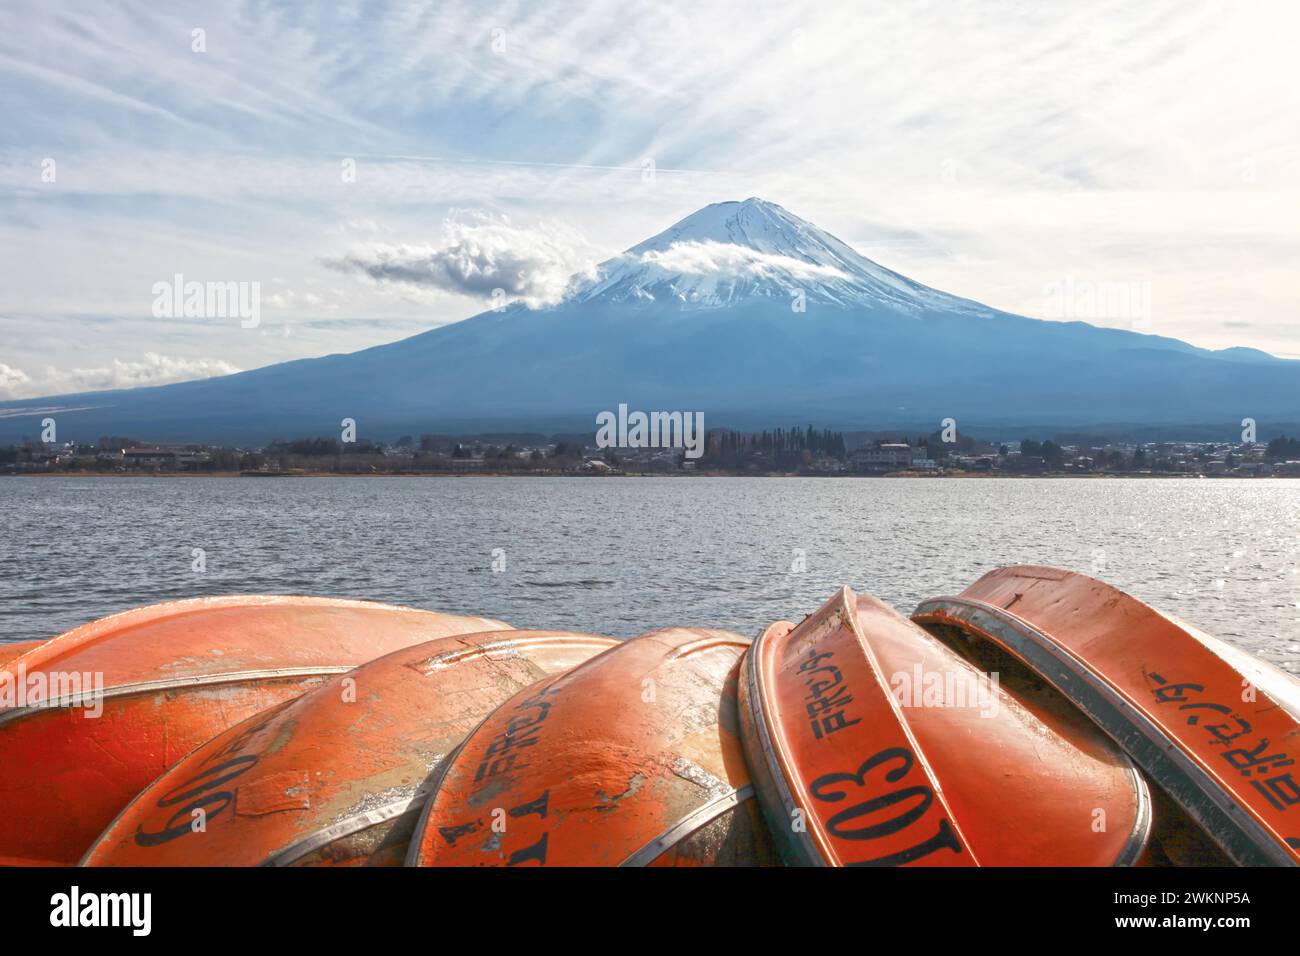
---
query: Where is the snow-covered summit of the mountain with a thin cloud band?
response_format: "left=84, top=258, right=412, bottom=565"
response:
left=572, top=198, right=979, bottom=312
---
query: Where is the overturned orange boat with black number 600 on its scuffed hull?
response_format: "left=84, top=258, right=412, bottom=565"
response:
left=82, top=631, right=619, bottom=866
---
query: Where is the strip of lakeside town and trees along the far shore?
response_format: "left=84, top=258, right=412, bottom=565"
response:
left=0, top=425, right=1300, bottom=477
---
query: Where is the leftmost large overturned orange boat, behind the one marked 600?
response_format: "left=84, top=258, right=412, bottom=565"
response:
left=0, top=597, right=508, bottom=865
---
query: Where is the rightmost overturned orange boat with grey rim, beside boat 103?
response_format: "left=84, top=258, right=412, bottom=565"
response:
left=913, top=566, right=1300, bottom=866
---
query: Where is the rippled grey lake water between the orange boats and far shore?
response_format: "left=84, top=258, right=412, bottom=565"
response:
left=0, top=477, right=1300, bottom=674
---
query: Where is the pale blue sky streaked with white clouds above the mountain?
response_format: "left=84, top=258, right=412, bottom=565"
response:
left=0, top=0, right=1300, bottom=397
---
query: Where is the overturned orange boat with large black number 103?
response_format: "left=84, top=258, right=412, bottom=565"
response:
left=740, top=588, right=1151, bottom=866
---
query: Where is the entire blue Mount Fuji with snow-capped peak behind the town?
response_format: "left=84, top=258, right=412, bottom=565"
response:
left=0, top=199, right=1300, bottom=444
